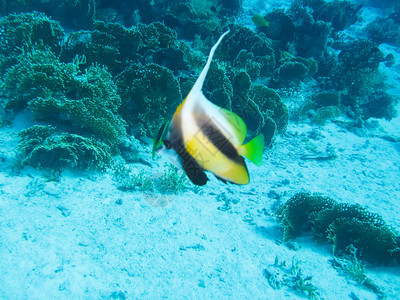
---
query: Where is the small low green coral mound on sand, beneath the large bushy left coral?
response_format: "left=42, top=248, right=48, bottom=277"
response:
left=18, top=125, right=112, bottom=169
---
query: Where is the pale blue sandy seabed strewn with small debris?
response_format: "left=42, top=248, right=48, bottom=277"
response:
left=0, top=110, right=400, bottom=299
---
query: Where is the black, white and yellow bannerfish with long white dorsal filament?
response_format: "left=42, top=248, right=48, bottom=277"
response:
left=153, top=31, right=264, bottom=185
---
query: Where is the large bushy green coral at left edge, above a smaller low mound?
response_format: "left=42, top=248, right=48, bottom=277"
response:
left=3, top=50, right=125, bottom=144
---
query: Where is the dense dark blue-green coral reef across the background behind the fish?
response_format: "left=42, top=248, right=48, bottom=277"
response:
left=0, top=0, right=399, bottom=173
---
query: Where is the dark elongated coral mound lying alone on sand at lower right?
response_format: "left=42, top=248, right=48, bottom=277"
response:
left=277, top=193, right=400, bottom=263
